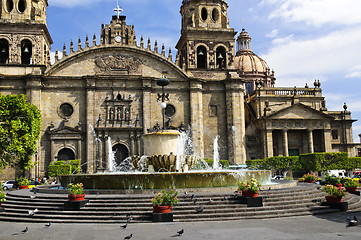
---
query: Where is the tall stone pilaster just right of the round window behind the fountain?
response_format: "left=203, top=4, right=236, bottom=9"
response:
left=190, top=79, right=204, bottom=158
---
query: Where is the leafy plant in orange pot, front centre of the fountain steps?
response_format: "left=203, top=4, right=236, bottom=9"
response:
left=151, top=189, right=178, bottom=213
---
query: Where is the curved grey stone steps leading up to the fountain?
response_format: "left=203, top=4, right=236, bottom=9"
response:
left=0, top=184, right=361, bottom=224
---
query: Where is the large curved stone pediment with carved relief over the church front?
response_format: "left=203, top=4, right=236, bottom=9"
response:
left=46, top=45, right=187, bottom=79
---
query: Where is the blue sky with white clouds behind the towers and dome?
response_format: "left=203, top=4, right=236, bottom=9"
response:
left=48, top=0, right=361, bottom=142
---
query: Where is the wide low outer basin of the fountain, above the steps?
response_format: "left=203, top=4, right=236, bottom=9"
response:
left=58, top=170, right=271, bottom=189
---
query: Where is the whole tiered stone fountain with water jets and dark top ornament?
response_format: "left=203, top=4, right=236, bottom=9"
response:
left=58, top=78, right=271, bottom=190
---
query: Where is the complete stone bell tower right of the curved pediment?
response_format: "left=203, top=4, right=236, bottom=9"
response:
left=176, top=0, right=236, bottom=70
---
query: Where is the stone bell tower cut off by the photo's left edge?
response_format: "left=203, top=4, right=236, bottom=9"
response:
left=0, top=0, right=53, bottom=67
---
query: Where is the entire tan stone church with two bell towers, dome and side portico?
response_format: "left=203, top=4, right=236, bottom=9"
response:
left=0, top=0, right=359, bottom=177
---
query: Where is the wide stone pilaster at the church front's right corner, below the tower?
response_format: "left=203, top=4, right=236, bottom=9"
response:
left=226, top=79, right=246, bottom=164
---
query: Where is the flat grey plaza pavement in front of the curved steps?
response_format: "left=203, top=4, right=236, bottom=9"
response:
left=0, top=211, right=361, bottom=240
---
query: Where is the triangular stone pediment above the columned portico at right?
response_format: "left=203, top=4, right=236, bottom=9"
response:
left=267, top=103, right=333, bottom=120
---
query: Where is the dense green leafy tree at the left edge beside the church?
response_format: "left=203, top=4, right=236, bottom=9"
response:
left=0, top=94, right=41, bottom=171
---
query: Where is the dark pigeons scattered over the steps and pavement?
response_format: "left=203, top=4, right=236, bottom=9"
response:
left=7, top=192, right=359, bottom=240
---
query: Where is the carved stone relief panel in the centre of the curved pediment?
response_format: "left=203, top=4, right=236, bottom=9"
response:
left=95, top=55, right=142, bottom=74
